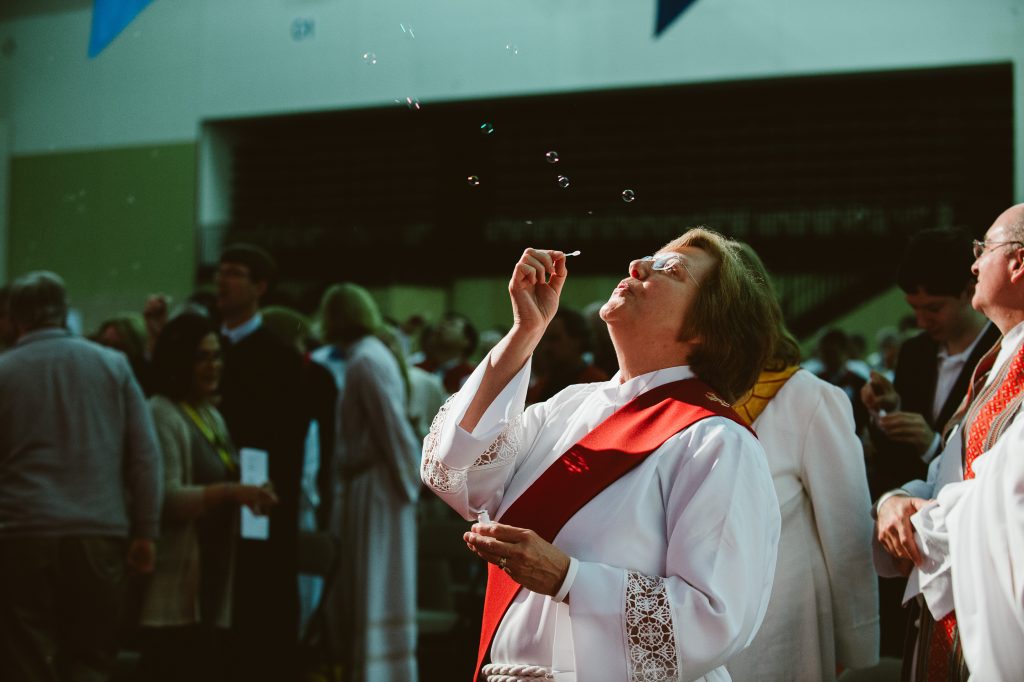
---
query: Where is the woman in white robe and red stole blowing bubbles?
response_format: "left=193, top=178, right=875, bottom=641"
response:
left=422, top=228, right=779, bottom=682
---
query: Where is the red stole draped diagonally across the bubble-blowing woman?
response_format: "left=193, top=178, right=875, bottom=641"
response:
left=473, top=379, right=753, bottom=680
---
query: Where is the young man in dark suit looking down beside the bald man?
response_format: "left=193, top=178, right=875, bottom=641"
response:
left=861, top=228, right=999, bottom=656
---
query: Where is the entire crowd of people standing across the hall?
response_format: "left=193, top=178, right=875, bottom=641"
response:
left=0, top=199, right=1024, bottom=682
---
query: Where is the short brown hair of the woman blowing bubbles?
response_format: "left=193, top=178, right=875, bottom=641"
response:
left=662, top=227, right=772, bottom=401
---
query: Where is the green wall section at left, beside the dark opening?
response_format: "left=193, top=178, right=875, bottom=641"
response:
left=7, top=143, right=197, bottom=333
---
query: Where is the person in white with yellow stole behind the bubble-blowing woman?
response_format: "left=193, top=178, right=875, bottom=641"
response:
left=726, top=247, right=879, bottom=682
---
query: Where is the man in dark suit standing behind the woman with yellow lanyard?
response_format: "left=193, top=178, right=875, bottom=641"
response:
left=216, top=244, right=308, bottom=680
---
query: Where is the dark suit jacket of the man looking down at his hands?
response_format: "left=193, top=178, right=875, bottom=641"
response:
left=870, top=323, right=999, bottom=499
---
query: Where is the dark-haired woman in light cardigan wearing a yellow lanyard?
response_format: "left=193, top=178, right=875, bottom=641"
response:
left=140, top=313, right=278, bottom=680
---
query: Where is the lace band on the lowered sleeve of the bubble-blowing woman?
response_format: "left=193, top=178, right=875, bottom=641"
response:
left=626, top=571, right=679, bottom=682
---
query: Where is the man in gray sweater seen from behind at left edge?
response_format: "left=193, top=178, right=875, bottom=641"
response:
left=0, top=271, right=162, bottom=680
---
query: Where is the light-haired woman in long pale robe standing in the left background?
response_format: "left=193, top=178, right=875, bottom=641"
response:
left=323, top=284, right=420, bottom=682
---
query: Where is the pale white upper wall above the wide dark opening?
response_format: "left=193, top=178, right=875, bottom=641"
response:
left=0, top=0, right=1024, bottom=197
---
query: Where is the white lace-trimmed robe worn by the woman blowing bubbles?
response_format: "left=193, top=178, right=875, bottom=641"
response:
left=422, top=361, right=780, bottom=682
